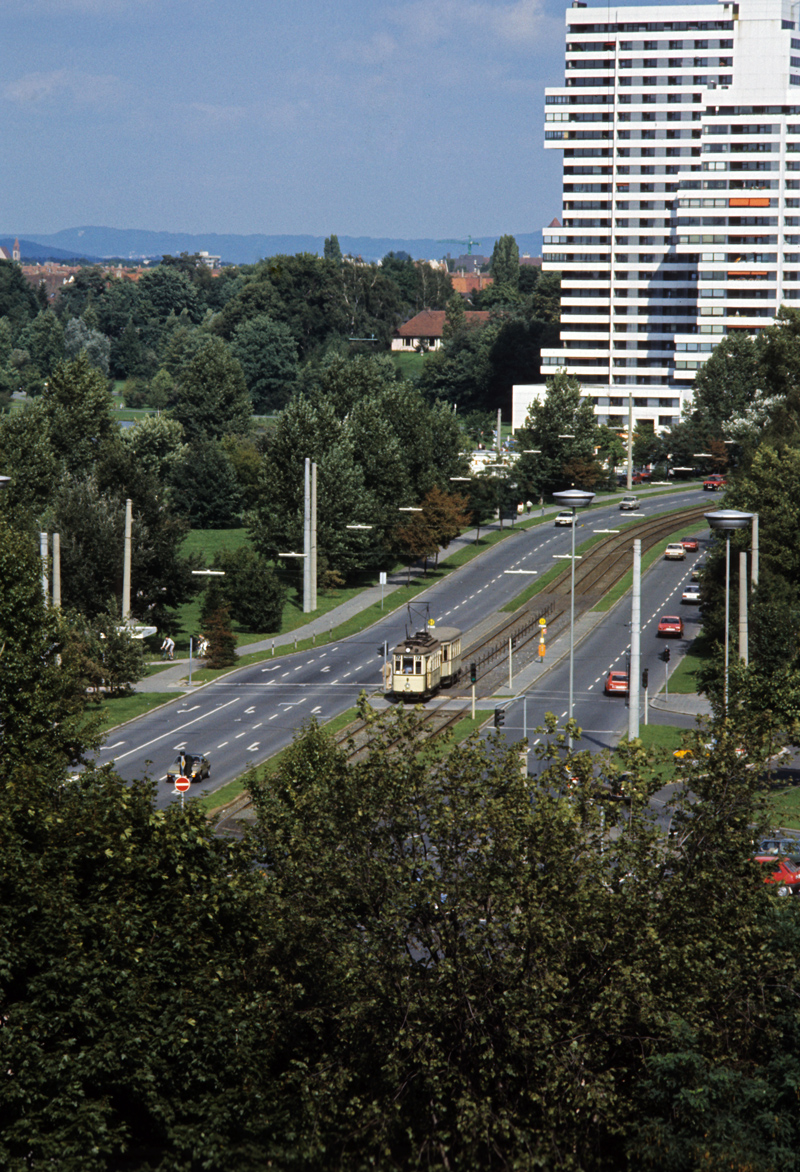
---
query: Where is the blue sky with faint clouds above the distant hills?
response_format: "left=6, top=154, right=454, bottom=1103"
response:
left=0, top=0, right=655, bottom=240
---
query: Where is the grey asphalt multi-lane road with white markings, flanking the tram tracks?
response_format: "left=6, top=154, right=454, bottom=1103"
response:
left=97, top=489, right=713, bottom=806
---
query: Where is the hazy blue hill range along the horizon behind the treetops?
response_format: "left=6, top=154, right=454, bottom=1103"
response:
left=0, top=227, right=541, bottom=265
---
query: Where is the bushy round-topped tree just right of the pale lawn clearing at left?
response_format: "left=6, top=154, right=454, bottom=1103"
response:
left=170, top=338, right=252, bottom=443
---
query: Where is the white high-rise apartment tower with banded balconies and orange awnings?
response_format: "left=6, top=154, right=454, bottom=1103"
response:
left=541, top=0, right=800, bottom=429
